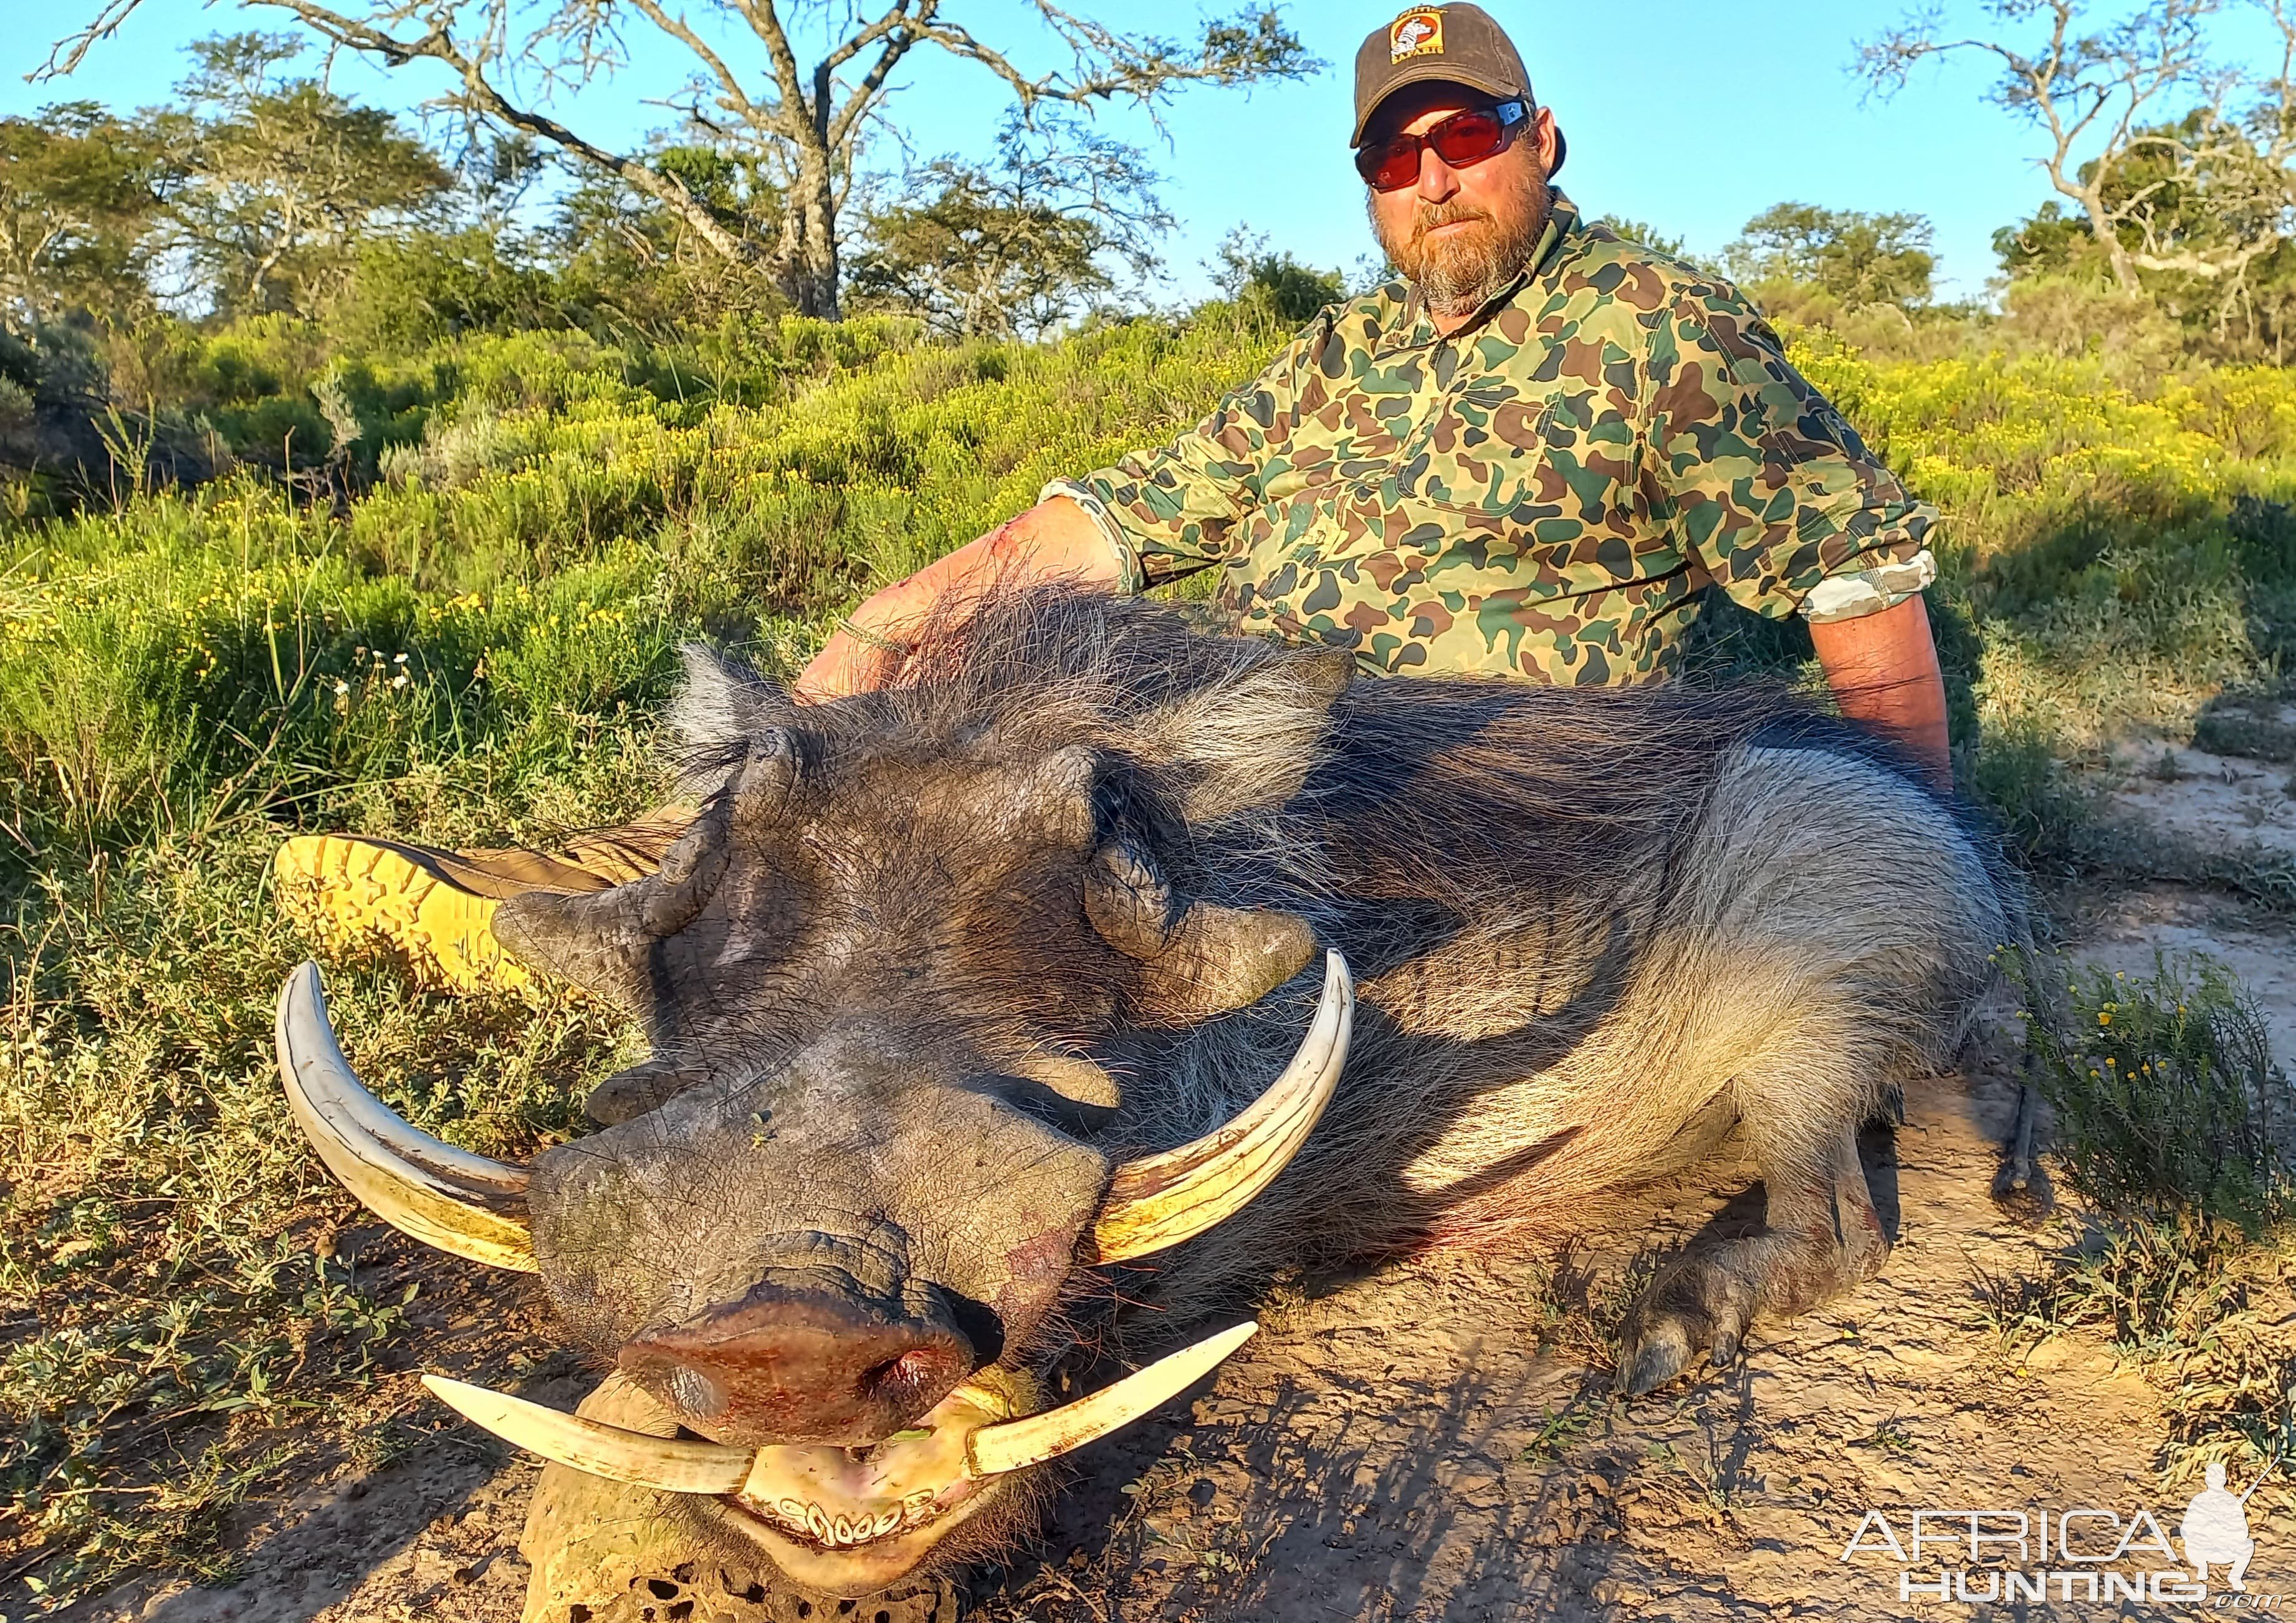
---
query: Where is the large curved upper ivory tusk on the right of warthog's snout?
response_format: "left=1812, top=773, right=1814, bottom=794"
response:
left=1093, top=953, right=1355, bottom=1263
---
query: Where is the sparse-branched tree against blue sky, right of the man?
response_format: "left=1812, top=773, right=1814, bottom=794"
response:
left=1857, top=0, right=2296, bottom=294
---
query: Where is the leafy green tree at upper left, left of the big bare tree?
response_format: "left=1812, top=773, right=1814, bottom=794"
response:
left=156, top=34, right=454, bottom=312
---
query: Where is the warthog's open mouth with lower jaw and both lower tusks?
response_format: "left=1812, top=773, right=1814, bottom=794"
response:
left=423, top=1323, right=1258, bottom=1596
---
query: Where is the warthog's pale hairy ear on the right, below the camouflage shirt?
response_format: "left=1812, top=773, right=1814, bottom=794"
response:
left=1125, top=648, right=1355, bottom=824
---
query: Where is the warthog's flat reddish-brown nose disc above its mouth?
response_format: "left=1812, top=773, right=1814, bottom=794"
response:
left=618, top=1286, right=980, bottom=1446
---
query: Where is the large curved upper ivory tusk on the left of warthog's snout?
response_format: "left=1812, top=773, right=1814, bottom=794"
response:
left=278, top=962, right=535, bottom=1271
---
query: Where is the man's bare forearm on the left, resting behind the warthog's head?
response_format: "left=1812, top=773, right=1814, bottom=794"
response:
left=795, top=496, right=1125, bottom=705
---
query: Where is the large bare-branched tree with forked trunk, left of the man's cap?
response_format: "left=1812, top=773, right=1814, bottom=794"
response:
left=44, top=0, right=1320, bottom=317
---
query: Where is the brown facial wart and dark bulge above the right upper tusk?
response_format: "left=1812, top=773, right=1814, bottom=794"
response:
left=1084, top=836, right=1316, bottom=1026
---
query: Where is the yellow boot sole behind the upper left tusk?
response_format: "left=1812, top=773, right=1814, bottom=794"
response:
left=271, top=833, right=533, bottom=992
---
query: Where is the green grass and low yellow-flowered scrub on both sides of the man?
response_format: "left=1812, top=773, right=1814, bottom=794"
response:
left=0, top=310, right=2296, bottom=1614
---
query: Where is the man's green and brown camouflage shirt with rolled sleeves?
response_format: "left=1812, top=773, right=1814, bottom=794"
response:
left=1047, top=195, right=1936, bottom=682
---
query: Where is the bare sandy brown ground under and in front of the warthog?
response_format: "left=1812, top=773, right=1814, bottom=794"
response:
left=54, top=769, right=2296, bottom=1623
